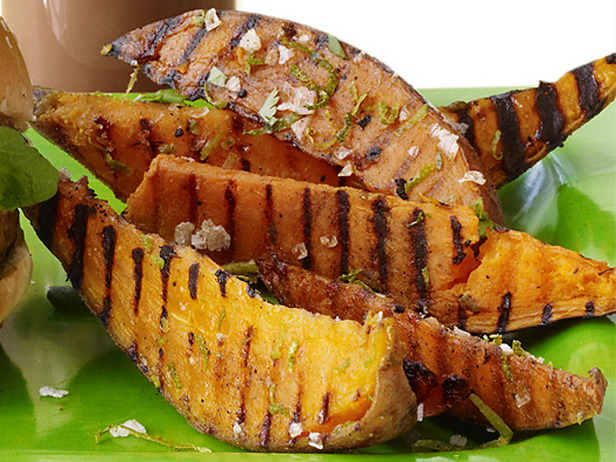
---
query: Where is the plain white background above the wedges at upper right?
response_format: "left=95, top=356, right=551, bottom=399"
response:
left=236, top=0, right=616, bottom=88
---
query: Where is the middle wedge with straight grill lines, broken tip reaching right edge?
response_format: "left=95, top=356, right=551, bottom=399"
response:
left=125, top=155, right=616, bottom=333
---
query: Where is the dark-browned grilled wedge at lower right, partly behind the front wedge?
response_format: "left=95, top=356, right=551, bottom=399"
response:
left=257, top=252, right=607, bottom=430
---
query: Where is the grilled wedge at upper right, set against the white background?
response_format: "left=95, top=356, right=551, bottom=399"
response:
left=439, top=53, right=616, bottom=187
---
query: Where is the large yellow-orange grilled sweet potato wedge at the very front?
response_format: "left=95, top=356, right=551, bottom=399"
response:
left=26, top=176, right=417, bottom=451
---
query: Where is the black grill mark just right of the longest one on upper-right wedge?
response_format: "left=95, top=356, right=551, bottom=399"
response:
left=535, top=82, right=567, bottom=147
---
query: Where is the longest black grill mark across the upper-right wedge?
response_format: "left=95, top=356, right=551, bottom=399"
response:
left=491, top=92, right=526, bottom=180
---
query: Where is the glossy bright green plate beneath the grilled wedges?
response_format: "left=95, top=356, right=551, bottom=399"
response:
left=0, top=89, right=616, bottom=462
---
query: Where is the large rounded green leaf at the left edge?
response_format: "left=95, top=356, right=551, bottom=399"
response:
left=0, top=127, right=58, bottom=210
